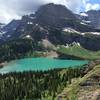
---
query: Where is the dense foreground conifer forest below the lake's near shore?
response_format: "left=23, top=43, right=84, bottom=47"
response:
left=0, top=68, right=82, bottom=100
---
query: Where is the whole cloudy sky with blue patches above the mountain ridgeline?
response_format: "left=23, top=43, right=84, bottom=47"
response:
left=0, top=0, right=100, bottom=23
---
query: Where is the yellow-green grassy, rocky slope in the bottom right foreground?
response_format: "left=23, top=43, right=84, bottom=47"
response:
left=59, top=65, right=100, bottom=100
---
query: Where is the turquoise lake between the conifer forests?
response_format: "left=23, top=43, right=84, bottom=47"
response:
left=0, top=58, right=88, bottom=73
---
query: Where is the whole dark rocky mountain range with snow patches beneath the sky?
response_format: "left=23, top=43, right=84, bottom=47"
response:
left=0, top=3, right=100, bottom=50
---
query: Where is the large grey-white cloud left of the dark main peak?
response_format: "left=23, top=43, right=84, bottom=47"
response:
left=0, top=0, right=40, bottom=23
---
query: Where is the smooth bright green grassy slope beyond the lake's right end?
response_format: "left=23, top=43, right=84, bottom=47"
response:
left=57, top=45, right=100, bottom=60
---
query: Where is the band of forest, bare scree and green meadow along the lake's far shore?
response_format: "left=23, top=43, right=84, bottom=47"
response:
left=0, top=38, right=100, bottom=62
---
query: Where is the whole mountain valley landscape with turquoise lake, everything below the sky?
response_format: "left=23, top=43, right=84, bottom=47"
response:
left=0, top=3, right=100, bottom=100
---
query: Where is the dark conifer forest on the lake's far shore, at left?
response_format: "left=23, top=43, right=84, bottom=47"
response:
left=0, top=39, right=45, bottom=62
